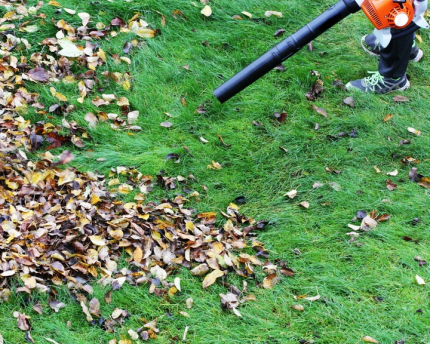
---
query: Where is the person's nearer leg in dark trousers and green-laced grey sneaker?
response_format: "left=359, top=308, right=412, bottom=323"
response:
left=346, top=30, right=414, bottom=93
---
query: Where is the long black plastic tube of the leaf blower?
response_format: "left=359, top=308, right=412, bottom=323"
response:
left=214, top=0, right=360, bottom=103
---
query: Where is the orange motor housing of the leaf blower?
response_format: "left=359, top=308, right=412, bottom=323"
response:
left=361, top=0, right=414, bottom=30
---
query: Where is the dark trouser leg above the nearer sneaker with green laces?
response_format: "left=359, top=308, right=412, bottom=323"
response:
left=379, top=30, right=415, bottom=79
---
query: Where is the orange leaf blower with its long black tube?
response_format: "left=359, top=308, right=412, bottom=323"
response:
left=214, top=0, right=429, bottom=103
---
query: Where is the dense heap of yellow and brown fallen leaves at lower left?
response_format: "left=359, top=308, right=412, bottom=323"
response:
left=0, top=151, right=286, bottom=336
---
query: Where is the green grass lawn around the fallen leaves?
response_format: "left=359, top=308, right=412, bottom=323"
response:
left=0, top=0, right=430, bottom=344
